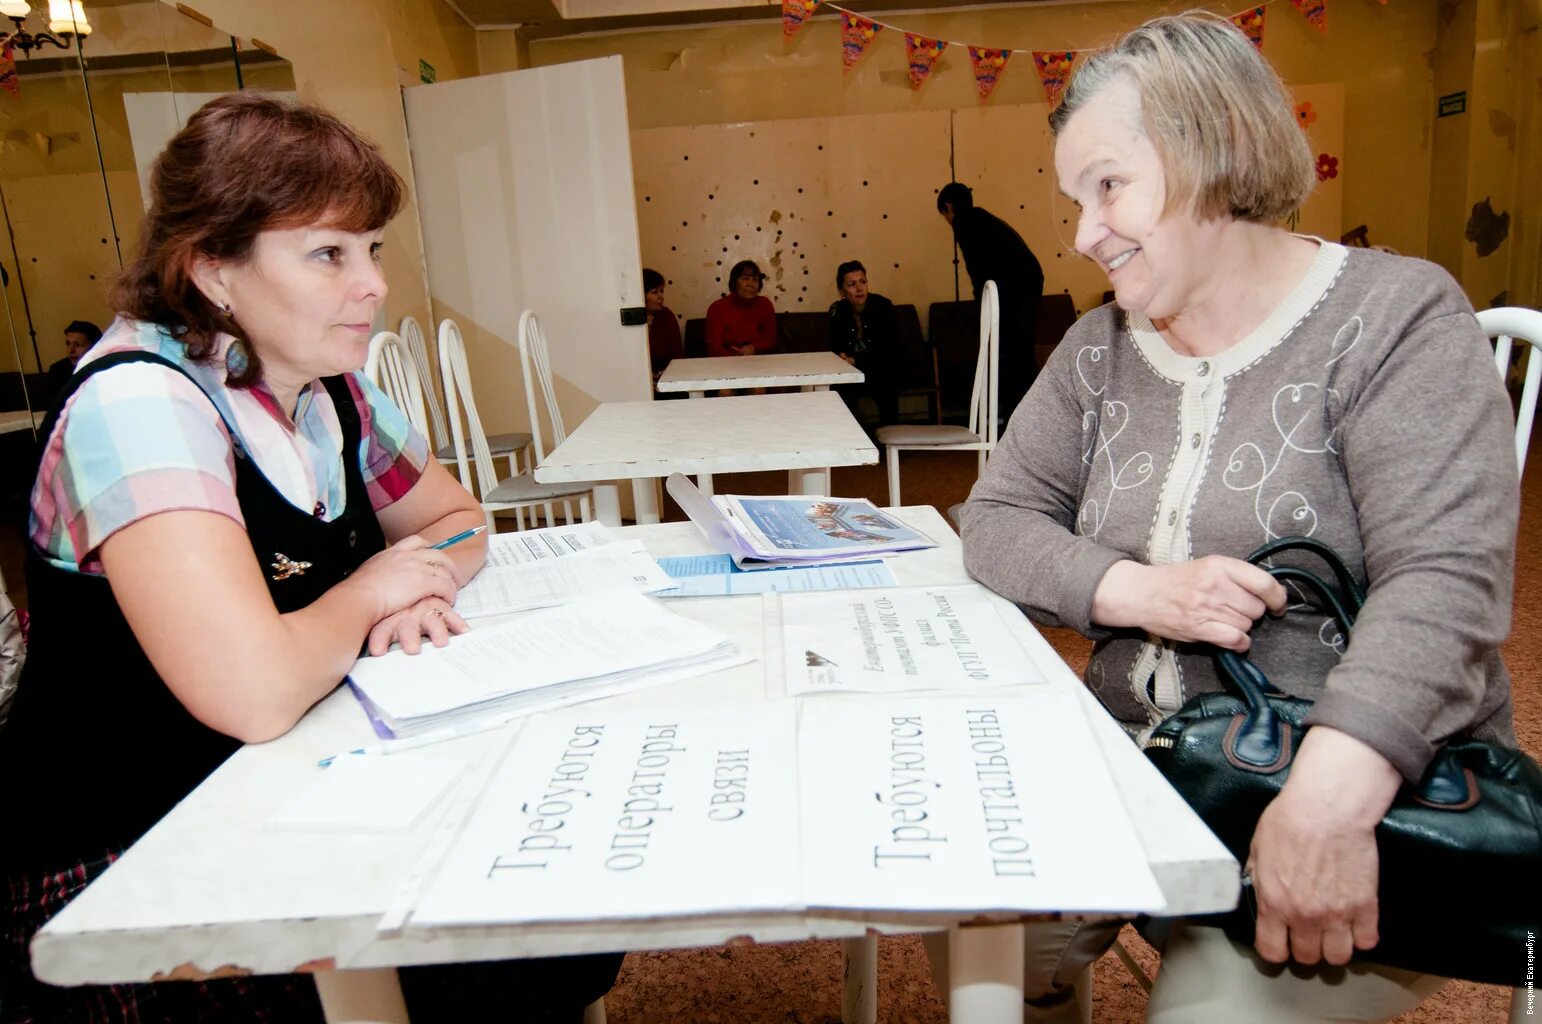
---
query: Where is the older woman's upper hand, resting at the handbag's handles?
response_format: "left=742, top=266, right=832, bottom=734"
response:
left=1092, top=555, right=1286, bottom=651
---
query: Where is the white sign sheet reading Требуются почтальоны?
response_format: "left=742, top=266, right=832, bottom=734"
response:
left=799, top=689, right=1163, bottom=913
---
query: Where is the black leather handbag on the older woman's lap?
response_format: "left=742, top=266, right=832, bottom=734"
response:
left=1146, top=537, right=1542, bottom=987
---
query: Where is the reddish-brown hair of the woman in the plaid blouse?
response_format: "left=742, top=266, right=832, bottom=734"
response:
left=113, top=93, right=404, bottom=387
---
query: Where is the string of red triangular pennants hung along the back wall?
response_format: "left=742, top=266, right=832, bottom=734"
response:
left=782, top=0, right=1356, bottom=98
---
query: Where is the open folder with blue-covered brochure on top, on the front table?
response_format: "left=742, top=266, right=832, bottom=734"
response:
left=665, top=473, right=936, bottom=569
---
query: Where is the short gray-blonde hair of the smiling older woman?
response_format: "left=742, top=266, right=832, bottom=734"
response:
left=1050, top=11, right=1315, bottom=222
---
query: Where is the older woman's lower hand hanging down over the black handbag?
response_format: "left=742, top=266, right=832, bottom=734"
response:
left=1247, top=725, right=1402, bottom=965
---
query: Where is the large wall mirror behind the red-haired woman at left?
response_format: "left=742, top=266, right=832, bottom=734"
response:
left=0, top=0, right=295, bottom=447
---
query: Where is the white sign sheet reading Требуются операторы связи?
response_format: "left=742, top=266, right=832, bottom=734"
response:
left=412, top=703, right=799, bottom=925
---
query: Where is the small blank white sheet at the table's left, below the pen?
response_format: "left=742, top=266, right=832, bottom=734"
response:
left=267, top=753, right=466, bottom=831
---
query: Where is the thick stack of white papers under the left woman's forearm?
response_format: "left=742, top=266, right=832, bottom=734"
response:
left=348, top=591, right=748, bottom=737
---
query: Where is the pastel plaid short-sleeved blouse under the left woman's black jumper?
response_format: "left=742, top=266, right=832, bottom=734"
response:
left=29, top=318, right=429, bottom=575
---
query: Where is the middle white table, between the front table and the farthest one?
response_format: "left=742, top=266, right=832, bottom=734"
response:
left=535, top=388, right=877, bottom=526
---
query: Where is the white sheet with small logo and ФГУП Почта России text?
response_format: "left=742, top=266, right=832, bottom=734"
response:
left=780, top=584, right=1044, bottom=696
